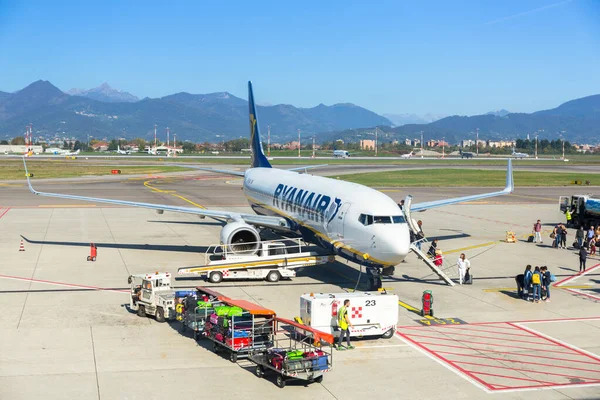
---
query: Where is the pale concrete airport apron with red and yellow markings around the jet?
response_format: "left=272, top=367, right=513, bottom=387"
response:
left=0, top=166, right=600, bottom=400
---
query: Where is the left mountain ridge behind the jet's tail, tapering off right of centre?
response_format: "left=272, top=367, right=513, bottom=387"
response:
left=0, top=80, right=391, bottom=142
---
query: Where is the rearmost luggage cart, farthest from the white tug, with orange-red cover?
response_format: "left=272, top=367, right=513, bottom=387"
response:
left=248, top=318, right=334, bottom=388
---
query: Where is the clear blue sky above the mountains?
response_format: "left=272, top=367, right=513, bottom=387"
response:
left=0, top=0, right=600, bottom=115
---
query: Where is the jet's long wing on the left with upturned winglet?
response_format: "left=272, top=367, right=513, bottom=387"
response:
left=23, top=157, right=290, bottom=229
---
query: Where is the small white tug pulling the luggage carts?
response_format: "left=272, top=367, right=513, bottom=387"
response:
left=127, top=272, right=176, bottom=322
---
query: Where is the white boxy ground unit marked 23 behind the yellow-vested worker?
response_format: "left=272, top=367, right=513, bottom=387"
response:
left=300, top=291, right=398, bottom=339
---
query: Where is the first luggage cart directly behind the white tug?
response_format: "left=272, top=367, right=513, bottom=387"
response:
left=179, top=287, right=225, bottom=340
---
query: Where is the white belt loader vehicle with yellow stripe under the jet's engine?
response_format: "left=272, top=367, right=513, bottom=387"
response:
left=177, top=239, right=335, bottom=283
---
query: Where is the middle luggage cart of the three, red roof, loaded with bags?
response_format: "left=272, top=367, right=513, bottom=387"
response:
left=204, top=297, right=275, bottom=362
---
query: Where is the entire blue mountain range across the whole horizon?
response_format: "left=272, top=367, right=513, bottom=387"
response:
left=0, top=80, right=600, bottom=143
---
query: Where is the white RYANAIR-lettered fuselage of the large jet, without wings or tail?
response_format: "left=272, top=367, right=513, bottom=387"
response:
left=244, top=168, right=410, bottom=266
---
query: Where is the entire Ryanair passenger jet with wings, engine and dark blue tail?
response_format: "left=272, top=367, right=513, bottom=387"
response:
left=23, top=82, right=513, bottom=282
